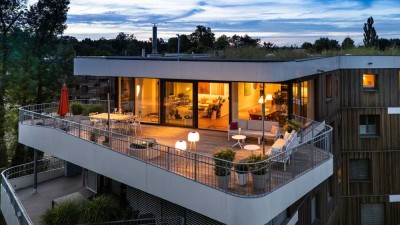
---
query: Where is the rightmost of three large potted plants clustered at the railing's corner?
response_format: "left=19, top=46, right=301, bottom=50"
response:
left=249, top=154, right=268, bottom=190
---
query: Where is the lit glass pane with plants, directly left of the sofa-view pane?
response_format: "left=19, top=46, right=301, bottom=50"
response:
left=164, top=82, right=193, bottom=127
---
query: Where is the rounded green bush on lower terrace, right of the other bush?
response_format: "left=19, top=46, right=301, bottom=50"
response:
left=83, top=195, right=120, bottom=224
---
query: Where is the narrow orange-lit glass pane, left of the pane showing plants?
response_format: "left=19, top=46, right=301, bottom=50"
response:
left=134, top=78, right=160, bottom=123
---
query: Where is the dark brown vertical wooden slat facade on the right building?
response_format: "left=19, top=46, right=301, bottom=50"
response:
left=335, top=69, right=400, bottom=224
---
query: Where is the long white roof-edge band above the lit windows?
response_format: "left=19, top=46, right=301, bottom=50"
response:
left=74, top=56, right=400, bottom=82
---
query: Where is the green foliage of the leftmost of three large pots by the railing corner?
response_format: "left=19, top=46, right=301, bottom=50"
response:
left=213, top=148, right=236, bottom=176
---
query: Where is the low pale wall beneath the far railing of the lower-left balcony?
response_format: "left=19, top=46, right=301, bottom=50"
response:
left=9, top=168, right=64, bottom=190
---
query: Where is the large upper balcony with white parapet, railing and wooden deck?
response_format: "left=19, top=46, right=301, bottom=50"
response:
left=6, top=103, right=333, bottom=224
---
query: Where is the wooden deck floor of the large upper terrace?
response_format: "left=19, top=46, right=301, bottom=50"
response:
left=22, top=119, right=329, bottom=196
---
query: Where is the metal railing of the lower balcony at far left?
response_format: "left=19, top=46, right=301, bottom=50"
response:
left=1, top=157, right=64, bottom=225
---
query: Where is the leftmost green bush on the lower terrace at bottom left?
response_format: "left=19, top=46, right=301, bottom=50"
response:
left=40, top=201, right=85, bottom=225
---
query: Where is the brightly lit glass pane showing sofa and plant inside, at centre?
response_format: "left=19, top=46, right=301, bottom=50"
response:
left=197, top=82, right=229, bottom=130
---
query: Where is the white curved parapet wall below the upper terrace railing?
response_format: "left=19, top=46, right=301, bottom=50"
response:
left=19, top=124, right=333, bottom=225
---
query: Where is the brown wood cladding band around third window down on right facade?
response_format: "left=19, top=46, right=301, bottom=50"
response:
left=342, top=151, right=400, bottom=196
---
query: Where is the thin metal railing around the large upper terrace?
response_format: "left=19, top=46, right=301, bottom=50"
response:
left=20, top=103, right=332, bottom=197
